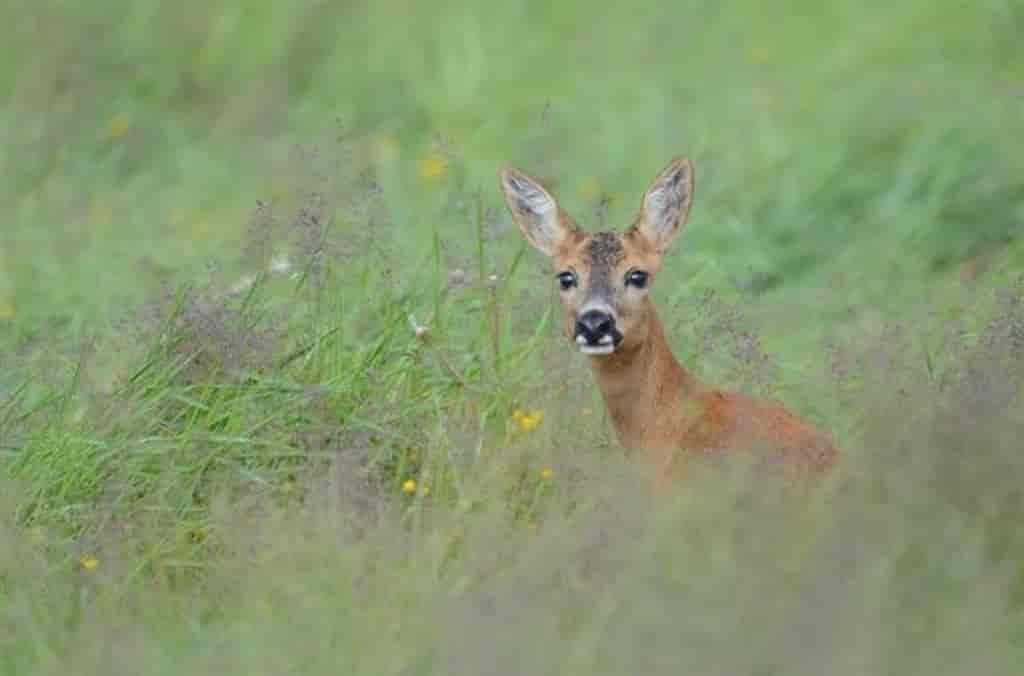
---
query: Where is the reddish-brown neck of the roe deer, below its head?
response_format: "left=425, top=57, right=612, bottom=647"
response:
left=591, top=307, right=695, bottom=450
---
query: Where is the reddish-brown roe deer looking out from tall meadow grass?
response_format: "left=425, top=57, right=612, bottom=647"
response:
left=501, top=158, right=837, bottom=490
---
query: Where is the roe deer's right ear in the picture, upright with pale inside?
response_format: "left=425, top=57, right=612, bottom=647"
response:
left=636, top=158, right=693, bottom=253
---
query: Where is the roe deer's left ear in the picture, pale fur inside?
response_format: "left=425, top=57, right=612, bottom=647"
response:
left=501, top=167, right=573, bottom=256
